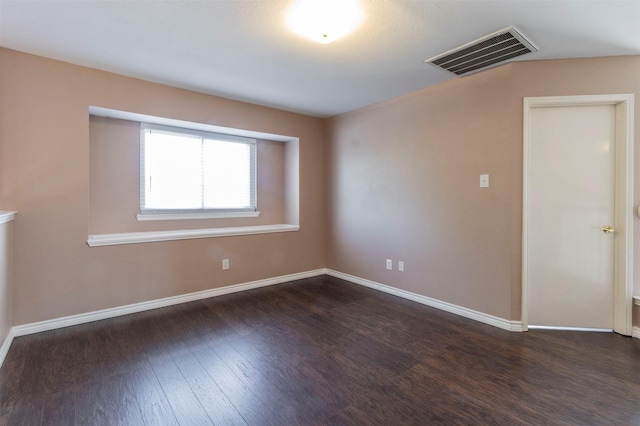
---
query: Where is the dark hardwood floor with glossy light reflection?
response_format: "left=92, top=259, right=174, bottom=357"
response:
left=0, top=277, right=640, bottom=425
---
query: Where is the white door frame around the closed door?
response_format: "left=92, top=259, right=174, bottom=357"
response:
left=522, top=94, right=634, bottom=336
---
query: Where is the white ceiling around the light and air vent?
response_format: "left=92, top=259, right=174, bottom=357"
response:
left=0, top=0, right=640, bottom=117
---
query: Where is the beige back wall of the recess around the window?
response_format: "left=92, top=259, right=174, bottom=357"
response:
left=89, top=116, right=285, bottom=234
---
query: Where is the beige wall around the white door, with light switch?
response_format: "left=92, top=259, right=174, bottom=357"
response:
left=326, top=56, right=640, bottom=325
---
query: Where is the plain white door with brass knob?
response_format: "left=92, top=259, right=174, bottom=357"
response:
left=526, top=105, right=616, bottom=330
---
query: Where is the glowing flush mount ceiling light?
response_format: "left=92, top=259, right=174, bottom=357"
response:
left=287, top=0, right=363, bottom=44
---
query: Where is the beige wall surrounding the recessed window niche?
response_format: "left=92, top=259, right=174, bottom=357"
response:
left=1, top=50, right=325, bottom=325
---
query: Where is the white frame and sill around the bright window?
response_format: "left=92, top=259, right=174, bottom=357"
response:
left=136, top=122, right=260, bottom=221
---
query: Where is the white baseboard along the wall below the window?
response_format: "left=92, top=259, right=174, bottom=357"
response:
left=9, top=269, right=325, bottom=336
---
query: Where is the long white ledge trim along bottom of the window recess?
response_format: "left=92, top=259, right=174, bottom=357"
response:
left=87, top=224, right=300, bottom=247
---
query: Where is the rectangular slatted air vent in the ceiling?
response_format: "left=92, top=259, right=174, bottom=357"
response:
left=425, top=27, right=538, bottom=76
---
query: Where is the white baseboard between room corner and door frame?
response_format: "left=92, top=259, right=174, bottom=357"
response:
left=327, top=269, right=522, bottom=332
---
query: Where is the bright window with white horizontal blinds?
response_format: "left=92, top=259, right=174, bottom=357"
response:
left=140, top=124, right=256, bottom=216
